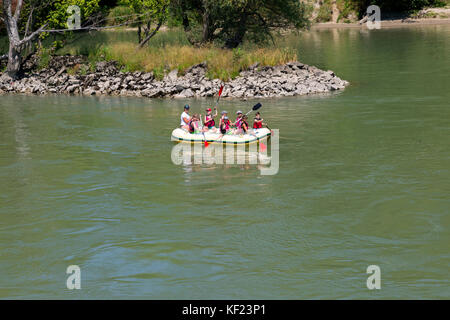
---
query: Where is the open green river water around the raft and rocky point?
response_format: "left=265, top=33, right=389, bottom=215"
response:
left=0, top=26, right=450, bottom=299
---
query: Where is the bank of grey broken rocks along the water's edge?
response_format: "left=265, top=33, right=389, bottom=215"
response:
left=0, top=56, right=349, bottom=98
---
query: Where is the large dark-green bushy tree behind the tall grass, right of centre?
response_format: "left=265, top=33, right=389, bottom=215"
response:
left=171, top=0, right=309, bottom=48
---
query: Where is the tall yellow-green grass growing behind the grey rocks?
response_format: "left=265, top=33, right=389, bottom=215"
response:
left=52, top=29, right=297, bottom=81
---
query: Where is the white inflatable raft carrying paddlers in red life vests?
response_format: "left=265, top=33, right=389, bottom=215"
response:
left=171, top=128, right=270, bottom=145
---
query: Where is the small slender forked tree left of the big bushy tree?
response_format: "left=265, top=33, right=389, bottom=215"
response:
left=120, top=0, right=169, bottom=48
